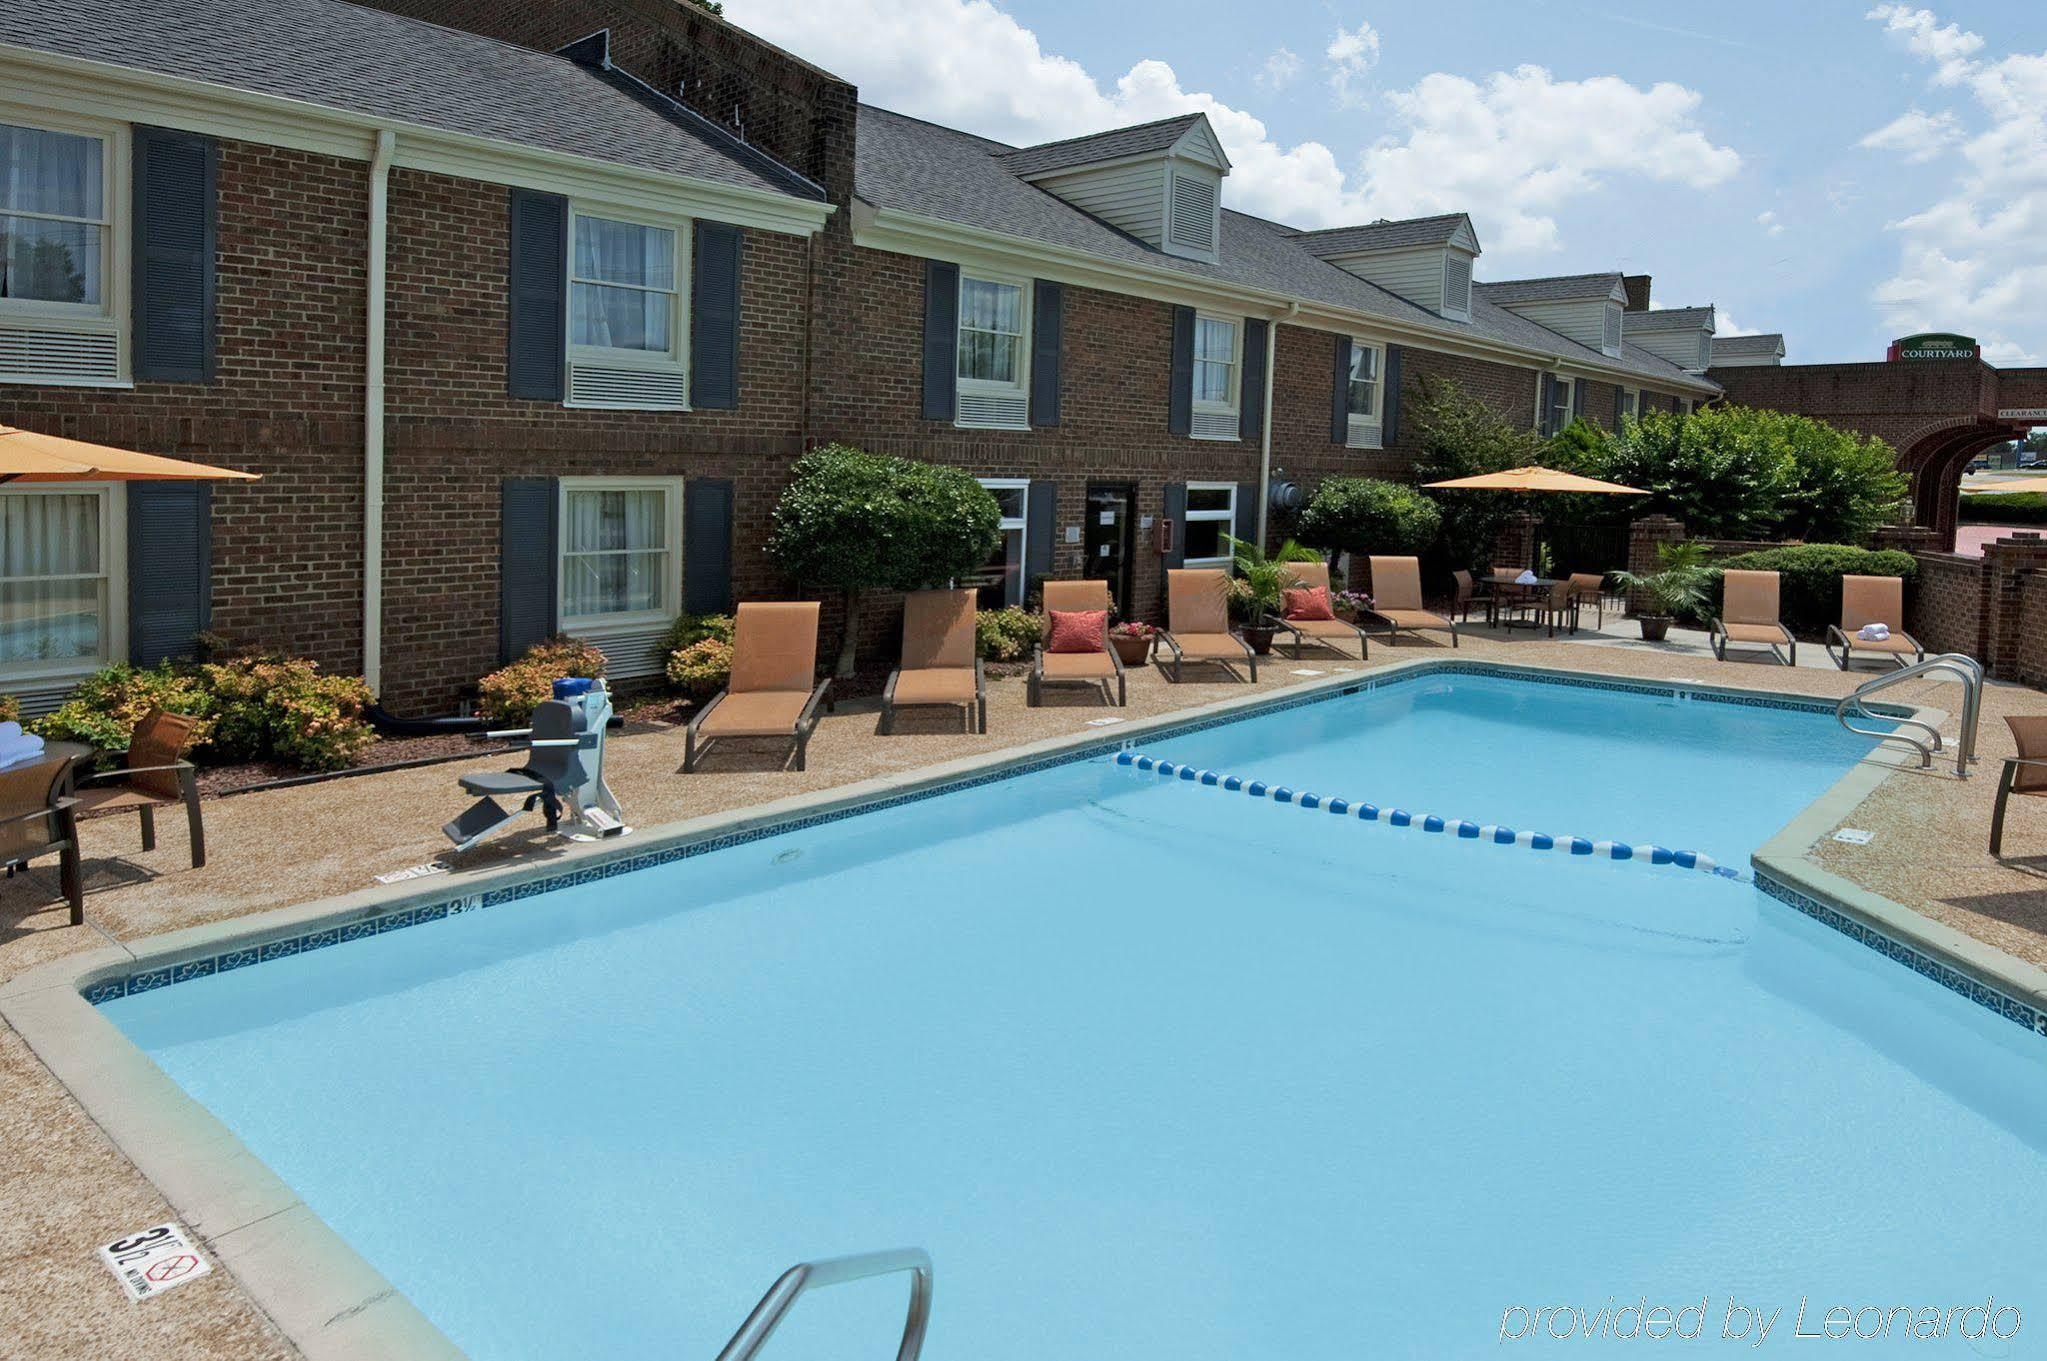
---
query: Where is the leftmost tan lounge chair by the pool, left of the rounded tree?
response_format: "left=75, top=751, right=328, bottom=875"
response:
left=682, top=600, right=831, bottom=774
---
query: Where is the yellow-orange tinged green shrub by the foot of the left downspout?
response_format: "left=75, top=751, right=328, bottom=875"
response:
left=199, top=657, right=377, bottom=770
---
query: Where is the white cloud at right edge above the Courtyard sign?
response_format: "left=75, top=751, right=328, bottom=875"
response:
left=1869, top=4, right=2047, bottom=362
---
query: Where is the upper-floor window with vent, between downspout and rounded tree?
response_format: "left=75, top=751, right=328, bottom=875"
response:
left=567, top=205, right=690, bottom=411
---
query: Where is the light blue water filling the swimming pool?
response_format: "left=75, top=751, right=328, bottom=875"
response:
left=106, top=673, right=2047, bottom=1361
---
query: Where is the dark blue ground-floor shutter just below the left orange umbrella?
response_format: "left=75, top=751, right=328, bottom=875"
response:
left=127, top=481, right=213, bottom=667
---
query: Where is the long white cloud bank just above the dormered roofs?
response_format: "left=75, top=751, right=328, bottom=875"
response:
left=727, top=0, right=1742, bottom=254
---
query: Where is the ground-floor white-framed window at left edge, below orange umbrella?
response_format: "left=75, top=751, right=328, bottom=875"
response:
left=0, top=483, right=127, bottom=686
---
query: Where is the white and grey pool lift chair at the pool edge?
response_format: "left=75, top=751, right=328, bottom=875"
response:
left=440, top=679, right=628, bottom=851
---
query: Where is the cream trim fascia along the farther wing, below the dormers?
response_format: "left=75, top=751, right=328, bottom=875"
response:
left=854, top=199, right=1719, bottom=397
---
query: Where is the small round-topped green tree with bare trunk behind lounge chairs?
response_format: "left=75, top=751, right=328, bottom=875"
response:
left=768, top=444, right=1003, bottom=675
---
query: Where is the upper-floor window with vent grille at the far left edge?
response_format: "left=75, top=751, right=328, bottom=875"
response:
left=0, top=106, right=129, bottom=387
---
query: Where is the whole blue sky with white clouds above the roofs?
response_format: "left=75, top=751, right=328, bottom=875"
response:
left=727, top=0, right=2047, bottom=364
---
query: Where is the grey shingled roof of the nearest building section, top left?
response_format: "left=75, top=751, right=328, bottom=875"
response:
left=0, top=0, right=825, bottom=201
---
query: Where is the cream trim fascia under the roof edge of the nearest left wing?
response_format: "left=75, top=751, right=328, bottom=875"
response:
left=0, top=45, right=833, bottom=235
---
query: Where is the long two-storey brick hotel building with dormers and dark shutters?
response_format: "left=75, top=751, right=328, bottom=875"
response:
left=0, top=0, right=1719, bottom=708
